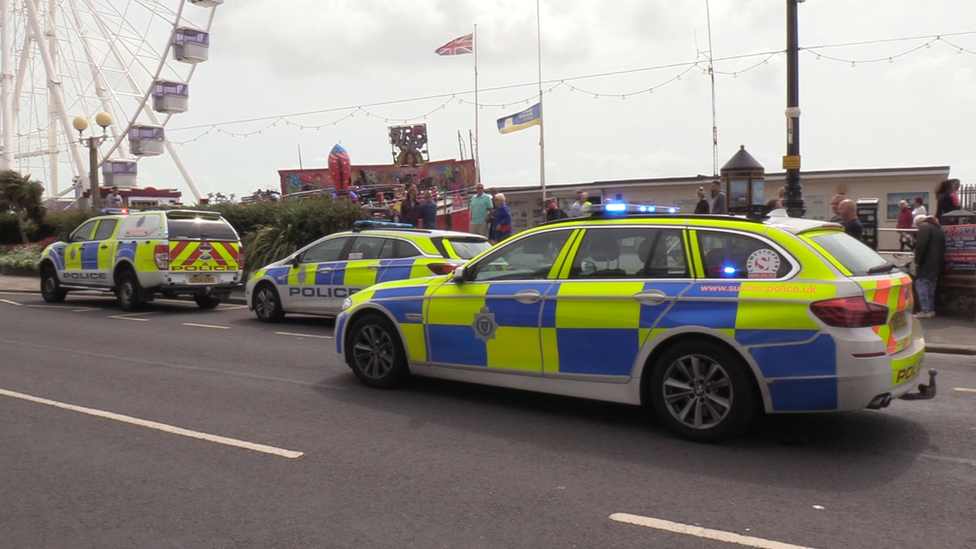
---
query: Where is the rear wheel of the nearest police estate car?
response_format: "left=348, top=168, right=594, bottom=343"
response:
left=648, top=340, right=757, bottom=442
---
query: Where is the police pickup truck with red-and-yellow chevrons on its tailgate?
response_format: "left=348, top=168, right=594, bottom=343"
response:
left=40, top=209, right=244, bottom=311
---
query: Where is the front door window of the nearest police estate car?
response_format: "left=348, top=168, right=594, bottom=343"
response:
left=465, top=230, right=572, bottom=281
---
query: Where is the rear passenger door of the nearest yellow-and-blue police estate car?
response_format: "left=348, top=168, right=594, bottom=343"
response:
left=541, top=226, right=693, bottom=376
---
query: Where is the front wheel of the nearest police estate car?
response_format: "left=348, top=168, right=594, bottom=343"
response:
left=346, top=314, right=410, bottom=389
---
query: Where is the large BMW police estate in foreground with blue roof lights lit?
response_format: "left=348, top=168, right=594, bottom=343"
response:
left=335, top=203, right=935, bottom=441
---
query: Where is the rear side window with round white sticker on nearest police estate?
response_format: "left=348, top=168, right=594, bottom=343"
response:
left=698, top=231, right=792, bottom=279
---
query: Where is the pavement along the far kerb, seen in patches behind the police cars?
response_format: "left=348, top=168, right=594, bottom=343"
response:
left=0, top=276, right=976, bottom=356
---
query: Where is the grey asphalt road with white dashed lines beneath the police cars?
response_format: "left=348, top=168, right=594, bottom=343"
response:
left=0, top=288, right=976, bottom=549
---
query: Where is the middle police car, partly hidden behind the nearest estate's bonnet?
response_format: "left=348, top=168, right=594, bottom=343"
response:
left=245, top=221, right=490, bottom=322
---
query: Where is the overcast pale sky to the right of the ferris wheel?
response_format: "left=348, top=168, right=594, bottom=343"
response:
left=133, top=0, right=976, bottom=202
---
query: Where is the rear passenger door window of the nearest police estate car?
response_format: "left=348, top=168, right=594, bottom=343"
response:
left=569, top=227, right=688, bottom=279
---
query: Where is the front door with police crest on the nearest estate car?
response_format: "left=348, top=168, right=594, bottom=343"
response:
left=424, top=228, right=574, bottom=374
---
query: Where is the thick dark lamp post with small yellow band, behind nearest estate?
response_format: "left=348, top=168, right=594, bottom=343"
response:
left=783, top=0, right=806, bottom=217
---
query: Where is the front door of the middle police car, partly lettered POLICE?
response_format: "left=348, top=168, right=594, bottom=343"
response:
left=279, top=236, right=353, bottom=314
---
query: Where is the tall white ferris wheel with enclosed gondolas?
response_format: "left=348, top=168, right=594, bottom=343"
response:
left=0, top=0, right=223, bottom=200
